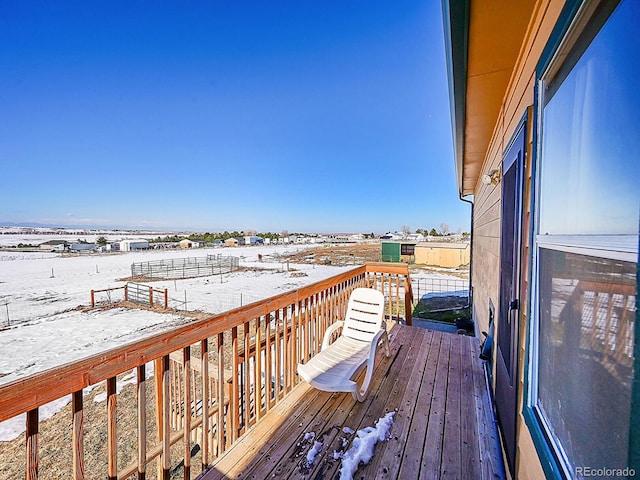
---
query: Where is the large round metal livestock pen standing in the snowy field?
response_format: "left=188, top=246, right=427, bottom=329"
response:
left=131, top=255, right=240, bottom=280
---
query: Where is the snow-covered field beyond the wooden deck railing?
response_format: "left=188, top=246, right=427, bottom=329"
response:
left=0, top=235, right=464, bottom=441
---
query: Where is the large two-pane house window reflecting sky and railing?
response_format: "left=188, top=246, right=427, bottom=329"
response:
left=525, top=0, right=640, bottom=478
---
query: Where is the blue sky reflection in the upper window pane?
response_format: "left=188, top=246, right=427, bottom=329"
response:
left=539, top=1, right=640, bottom=234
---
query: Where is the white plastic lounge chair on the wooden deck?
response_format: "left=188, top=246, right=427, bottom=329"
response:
left=298, top=288, right=389, bottom=402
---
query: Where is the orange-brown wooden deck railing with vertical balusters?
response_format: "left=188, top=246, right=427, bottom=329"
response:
left=0, top=264, right=412, bottom=480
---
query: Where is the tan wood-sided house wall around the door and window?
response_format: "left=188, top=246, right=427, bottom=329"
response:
left=472, top=0, right=565, bottom=479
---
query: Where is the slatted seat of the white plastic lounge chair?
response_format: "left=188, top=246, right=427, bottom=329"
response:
left=298, top=337, right=375, bottom=392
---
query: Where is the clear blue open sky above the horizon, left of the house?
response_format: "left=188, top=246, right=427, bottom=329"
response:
left=0, top=0, right=469, bottom=233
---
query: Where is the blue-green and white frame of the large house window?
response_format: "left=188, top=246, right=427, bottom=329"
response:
left=522, top=0, right=640, bottom=479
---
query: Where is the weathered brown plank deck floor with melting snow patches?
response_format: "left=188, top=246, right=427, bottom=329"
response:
left=201, top=325, right=504, bottom=480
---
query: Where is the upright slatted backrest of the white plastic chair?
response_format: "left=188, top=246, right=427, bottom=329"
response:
left=342, top=288, right=384, bottom=342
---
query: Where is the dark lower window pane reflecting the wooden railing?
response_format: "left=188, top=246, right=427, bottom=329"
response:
left=538, top=248, right=636, bottom=471
